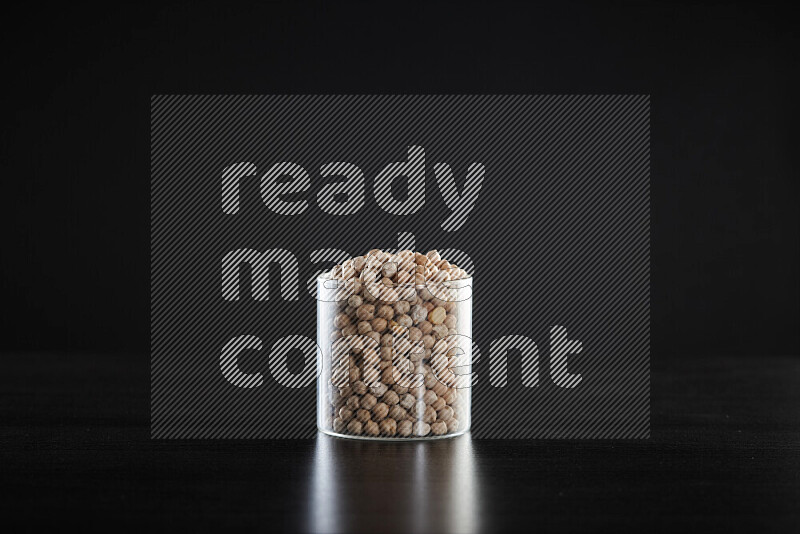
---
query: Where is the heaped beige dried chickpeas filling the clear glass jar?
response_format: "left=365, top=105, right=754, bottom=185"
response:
left=321, top=249, right=470, bottom=438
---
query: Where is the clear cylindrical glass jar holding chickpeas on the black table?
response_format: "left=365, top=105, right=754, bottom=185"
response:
left=317, top=273, right=472, bottom=440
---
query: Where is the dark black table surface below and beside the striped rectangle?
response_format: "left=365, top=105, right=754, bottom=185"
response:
left=0, top=353, right=800, bottom=533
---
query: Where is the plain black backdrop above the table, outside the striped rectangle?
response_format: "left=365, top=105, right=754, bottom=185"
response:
left=0, top=2, right=800, bottom=357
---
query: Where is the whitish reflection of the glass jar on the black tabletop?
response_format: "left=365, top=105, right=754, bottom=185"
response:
left=307, top=433, right=480, bottom=533
